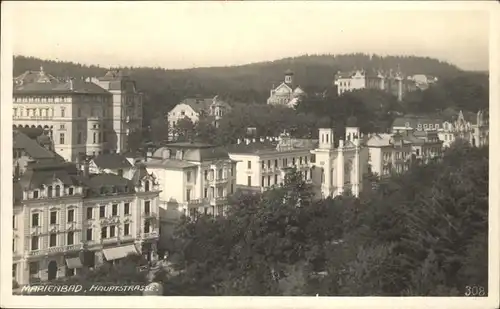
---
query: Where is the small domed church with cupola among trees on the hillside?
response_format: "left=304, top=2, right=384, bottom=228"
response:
left=267, top=70, right=306, bottom=107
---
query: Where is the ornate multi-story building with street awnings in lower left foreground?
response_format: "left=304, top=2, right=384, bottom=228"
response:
left=12, top=162, right=159, bottom=284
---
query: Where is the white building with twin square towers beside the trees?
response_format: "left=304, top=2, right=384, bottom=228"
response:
left=311, top=127, right=365, bottom=197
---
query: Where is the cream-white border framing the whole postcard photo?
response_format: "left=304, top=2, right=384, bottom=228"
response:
left=0, top=1, right=500, bottom=309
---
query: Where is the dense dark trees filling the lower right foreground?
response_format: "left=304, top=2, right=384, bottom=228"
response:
left=160, top=143, right=488, bottom=296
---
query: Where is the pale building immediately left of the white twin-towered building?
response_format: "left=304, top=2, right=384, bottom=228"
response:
left=227, top=133, right=317, bottom=191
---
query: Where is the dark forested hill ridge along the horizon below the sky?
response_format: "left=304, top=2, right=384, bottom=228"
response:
left=13, top=54, right=461, bottom=124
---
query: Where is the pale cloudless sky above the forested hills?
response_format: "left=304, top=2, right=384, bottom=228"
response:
left=2, top=1, right=495, bottom=70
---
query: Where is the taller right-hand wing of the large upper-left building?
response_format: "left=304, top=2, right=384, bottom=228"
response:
left=87, top=70, right=143, bottom=152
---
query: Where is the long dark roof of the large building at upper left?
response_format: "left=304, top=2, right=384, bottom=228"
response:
left=14, top=79, right=111, bottom=95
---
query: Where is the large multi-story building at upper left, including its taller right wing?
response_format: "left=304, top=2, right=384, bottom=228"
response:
left=13, top=68, right=142, bottom=161
